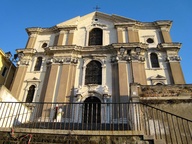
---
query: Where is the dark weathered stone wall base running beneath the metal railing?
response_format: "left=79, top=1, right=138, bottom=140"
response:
left=0, top=132, right=153, bottom=144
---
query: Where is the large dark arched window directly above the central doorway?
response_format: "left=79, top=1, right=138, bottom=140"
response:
left=85, top=60, right=102, bottom=85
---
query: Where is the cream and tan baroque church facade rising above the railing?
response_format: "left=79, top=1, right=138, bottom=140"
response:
left=11, top=12, right=185, bottom=103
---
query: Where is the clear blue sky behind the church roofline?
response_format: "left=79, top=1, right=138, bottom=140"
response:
left=0, top=0, right=192, bottom=83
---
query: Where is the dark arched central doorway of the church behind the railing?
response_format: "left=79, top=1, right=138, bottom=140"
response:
left=83, top=97, right=101, bottom=123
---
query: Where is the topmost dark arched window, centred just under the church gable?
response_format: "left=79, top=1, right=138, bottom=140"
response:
left=89, top=28, right=103, bottom=46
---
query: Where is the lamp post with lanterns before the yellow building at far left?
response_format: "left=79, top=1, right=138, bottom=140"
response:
left=3, top=51, right=24, bottom=86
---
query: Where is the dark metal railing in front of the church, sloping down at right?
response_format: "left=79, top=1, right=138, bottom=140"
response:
left=0, top=102, right=192, bottom=144
